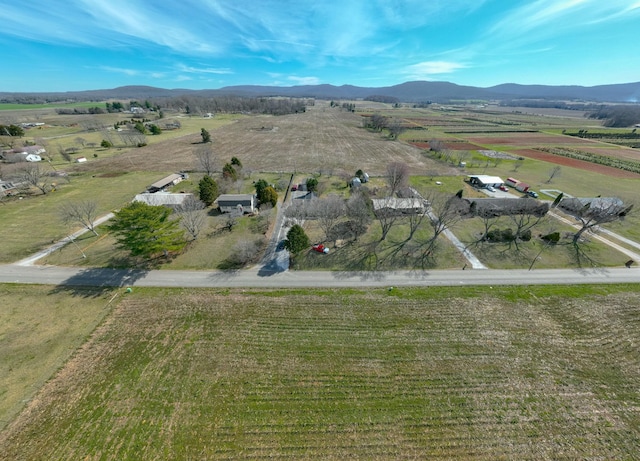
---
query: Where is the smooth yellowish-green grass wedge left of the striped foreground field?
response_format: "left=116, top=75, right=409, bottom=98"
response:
left=0, top=285, right=113, bottom=430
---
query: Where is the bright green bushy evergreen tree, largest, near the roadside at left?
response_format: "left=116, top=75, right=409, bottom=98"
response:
left=109, top=202, right=186, bottom=258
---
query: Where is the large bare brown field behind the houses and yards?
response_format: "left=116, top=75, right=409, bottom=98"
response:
left=92, top=105, right=456, bottom=175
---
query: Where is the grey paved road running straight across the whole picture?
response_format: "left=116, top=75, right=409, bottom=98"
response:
left=0, top=265, right=640, bottom=288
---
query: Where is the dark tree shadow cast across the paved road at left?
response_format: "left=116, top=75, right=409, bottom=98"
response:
left=51, top=268, right=149, bottom=298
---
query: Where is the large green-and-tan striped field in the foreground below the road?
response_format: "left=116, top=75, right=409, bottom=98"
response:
left=0, top=285, right=640, bottom=460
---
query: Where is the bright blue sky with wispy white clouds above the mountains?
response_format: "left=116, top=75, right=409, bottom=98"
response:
left=0, top=0, right=640, bottom=92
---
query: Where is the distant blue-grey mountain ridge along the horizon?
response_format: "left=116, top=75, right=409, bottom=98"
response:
left=0, top=81, right=640, bottom=103
